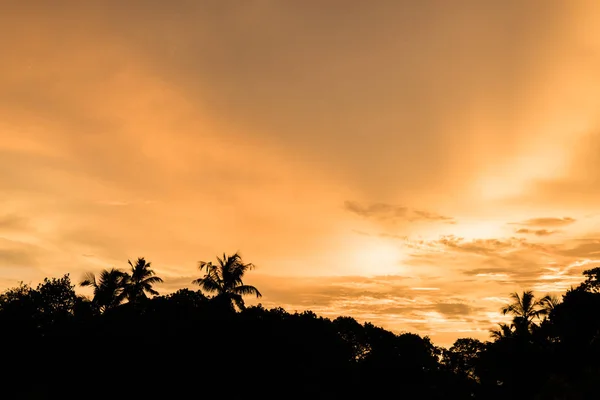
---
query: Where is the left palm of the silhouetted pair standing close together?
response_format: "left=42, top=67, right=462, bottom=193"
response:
left=79, top=268, right=126, bottom=312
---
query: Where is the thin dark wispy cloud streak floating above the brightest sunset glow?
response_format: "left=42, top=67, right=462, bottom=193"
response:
left=344, top=201, right=456, bottom=224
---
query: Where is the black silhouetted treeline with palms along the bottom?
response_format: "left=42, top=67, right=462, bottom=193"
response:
left=0, top=254, right=600, bottom=400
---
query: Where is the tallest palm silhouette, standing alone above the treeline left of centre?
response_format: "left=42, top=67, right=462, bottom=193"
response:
left=192, top=253, right=262, bottom=309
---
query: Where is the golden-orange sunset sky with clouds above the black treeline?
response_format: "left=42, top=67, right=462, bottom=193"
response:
left=0, top=0, right=600, bottom=345
